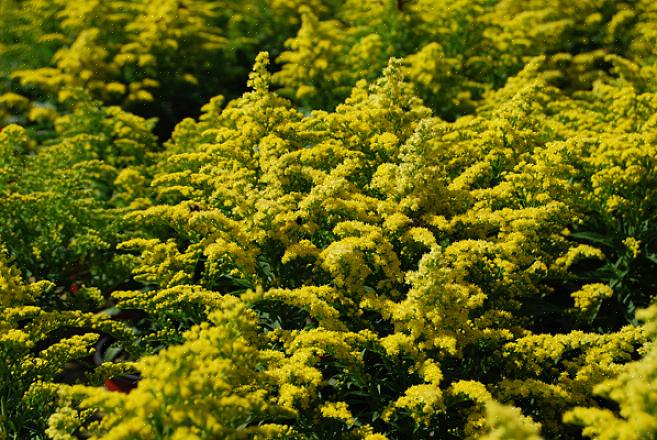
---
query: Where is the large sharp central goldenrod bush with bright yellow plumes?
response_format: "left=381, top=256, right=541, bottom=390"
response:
left=53, top=50, right=648, bottom=438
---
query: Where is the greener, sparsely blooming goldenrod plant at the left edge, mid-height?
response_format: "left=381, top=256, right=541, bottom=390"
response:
left=0, top=90, right=156, bottom=287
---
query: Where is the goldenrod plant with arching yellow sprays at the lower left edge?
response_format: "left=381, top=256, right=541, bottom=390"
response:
left=0, top=251, right=132, bottom=438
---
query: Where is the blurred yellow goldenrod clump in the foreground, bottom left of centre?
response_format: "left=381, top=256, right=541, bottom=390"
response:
left=49, top=297, right=292, bottom=439
